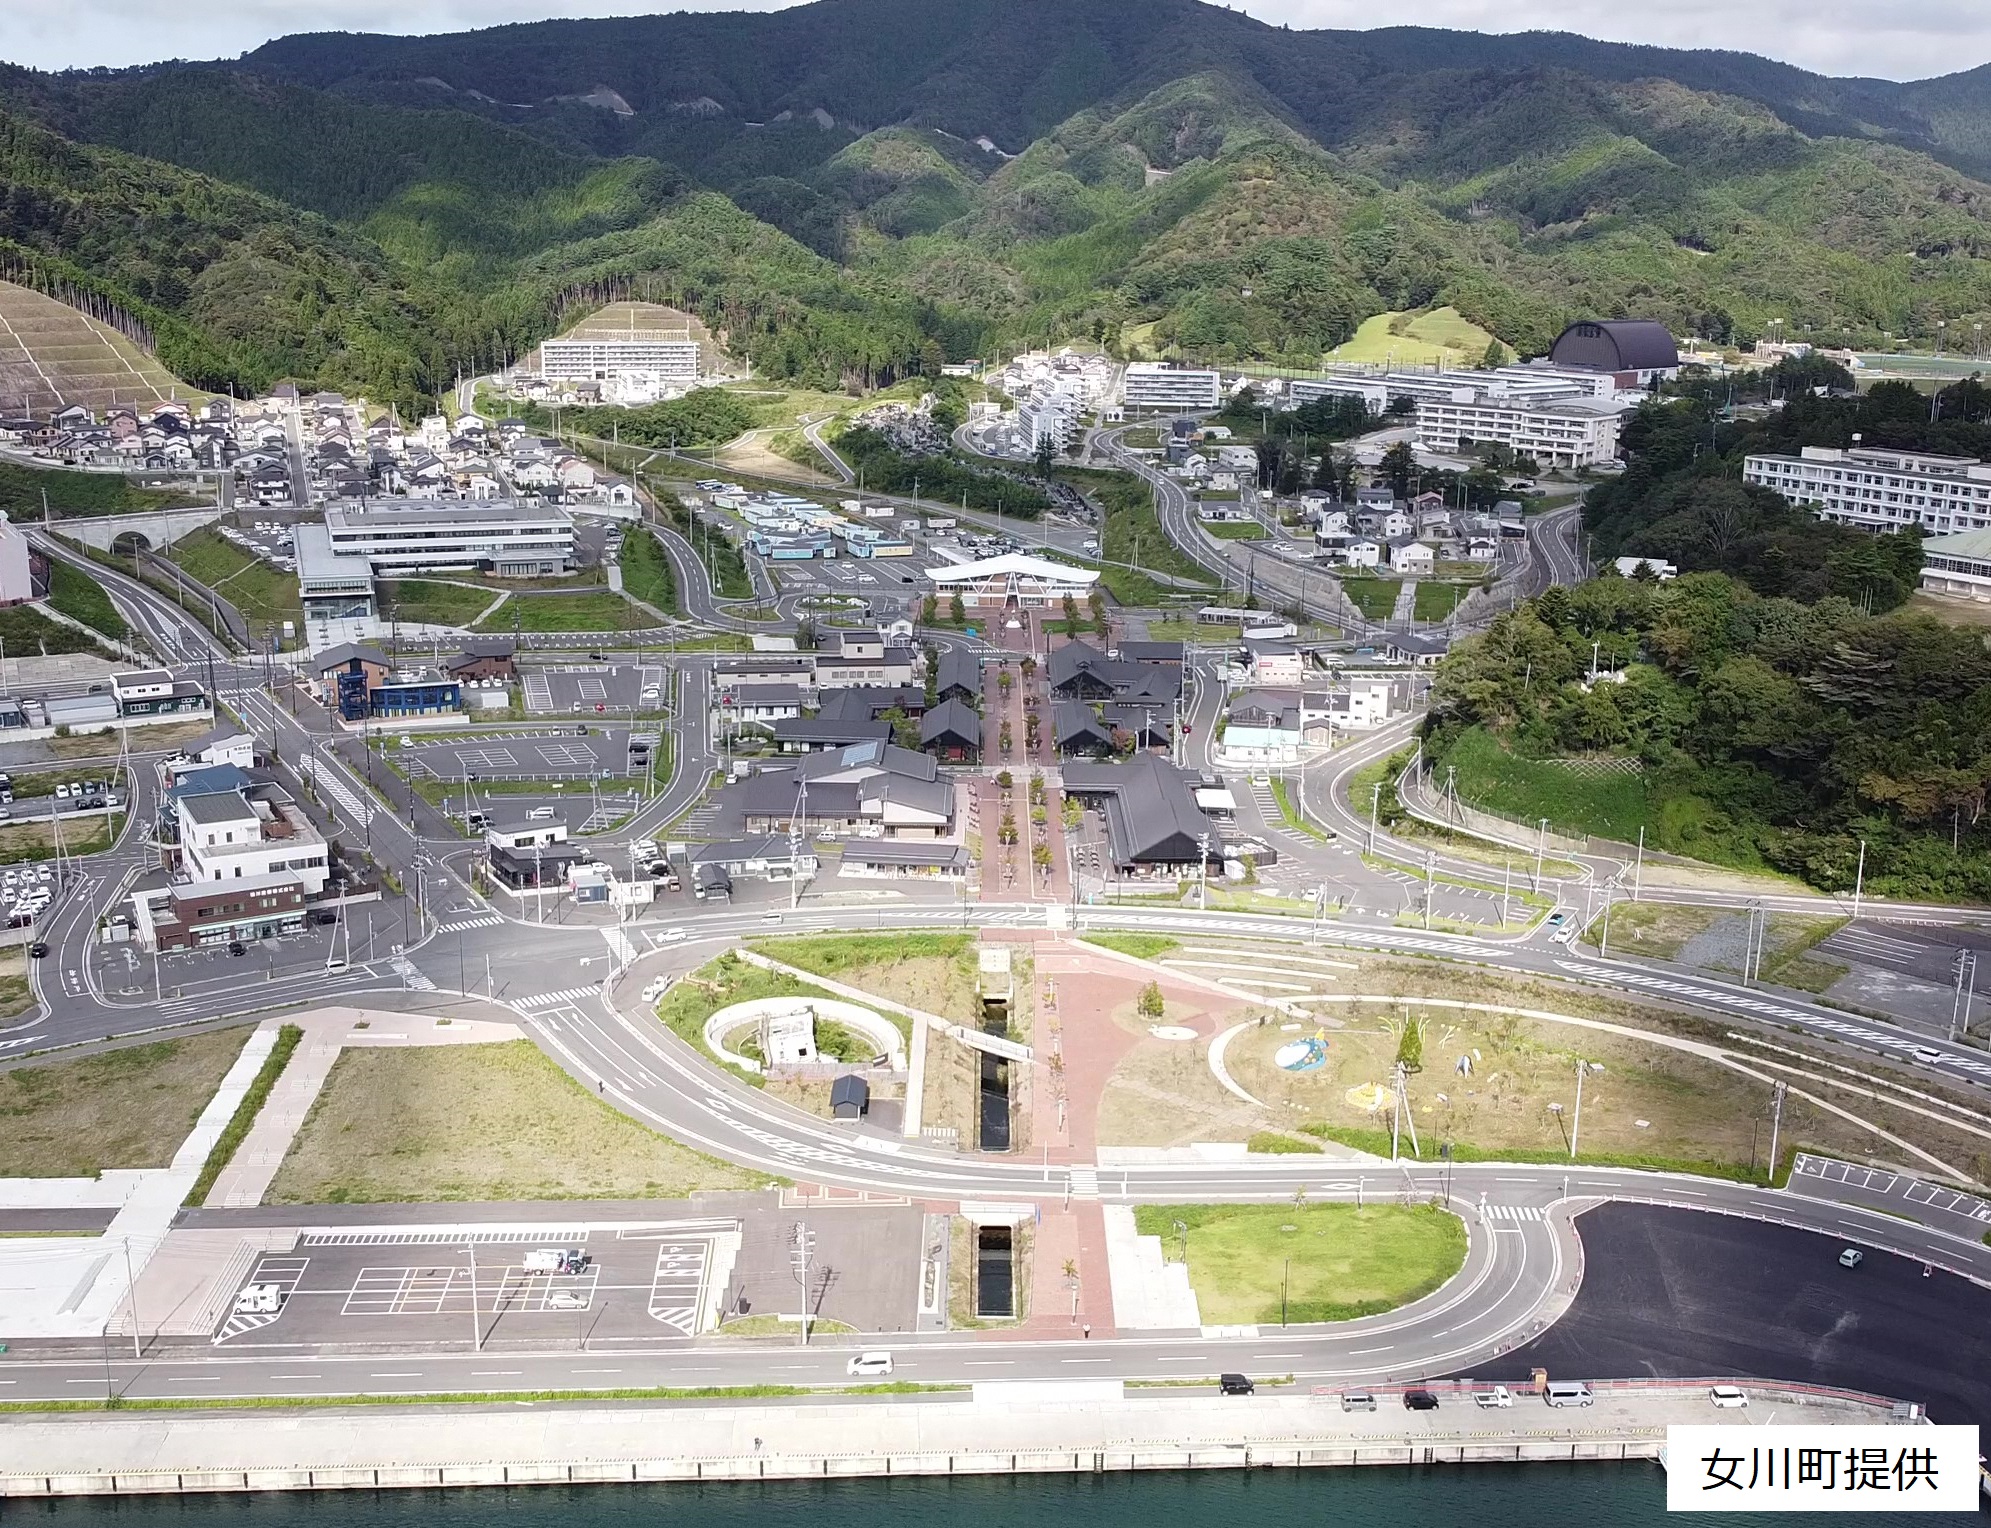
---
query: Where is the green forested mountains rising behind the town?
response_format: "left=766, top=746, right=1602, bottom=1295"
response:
left=15, top=0, right=1991, bottom=410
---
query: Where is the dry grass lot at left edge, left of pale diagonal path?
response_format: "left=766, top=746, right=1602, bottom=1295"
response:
left=0, top=1028, right=249, bottom=1177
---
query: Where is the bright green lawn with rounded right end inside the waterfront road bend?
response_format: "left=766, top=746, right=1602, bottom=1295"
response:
left=1133, top=1203, right=1465, bottom=1327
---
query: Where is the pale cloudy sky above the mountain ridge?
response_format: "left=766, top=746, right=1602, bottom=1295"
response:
left=0, top=0, right=1991, bottom=80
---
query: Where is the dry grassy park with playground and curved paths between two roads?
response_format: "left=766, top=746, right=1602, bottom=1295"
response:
left=1099, top=946, right=1991, bottom=1179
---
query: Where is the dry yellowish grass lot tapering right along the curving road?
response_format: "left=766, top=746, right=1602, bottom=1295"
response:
left=265, top=1040, right=767, bottom=1203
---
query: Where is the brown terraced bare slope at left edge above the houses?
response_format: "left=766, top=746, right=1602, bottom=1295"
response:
left=0, top=281, right=205, bottom=414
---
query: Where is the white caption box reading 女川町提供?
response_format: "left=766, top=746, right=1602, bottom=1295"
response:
left=1666, top=1422, right=1977, bottom=1512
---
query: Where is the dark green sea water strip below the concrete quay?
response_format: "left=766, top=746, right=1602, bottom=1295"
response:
left=4, top=1462, right=1985, bottom=1528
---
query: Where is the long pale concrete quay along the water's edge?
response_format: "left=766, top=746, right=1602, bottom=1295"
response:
left=0, top=1385, right=1887, bottom=1496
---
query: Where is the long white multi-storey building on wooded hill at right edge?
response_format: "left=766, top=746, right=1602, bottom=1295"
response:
left=1742, top=446, right=1991, bottom=536
